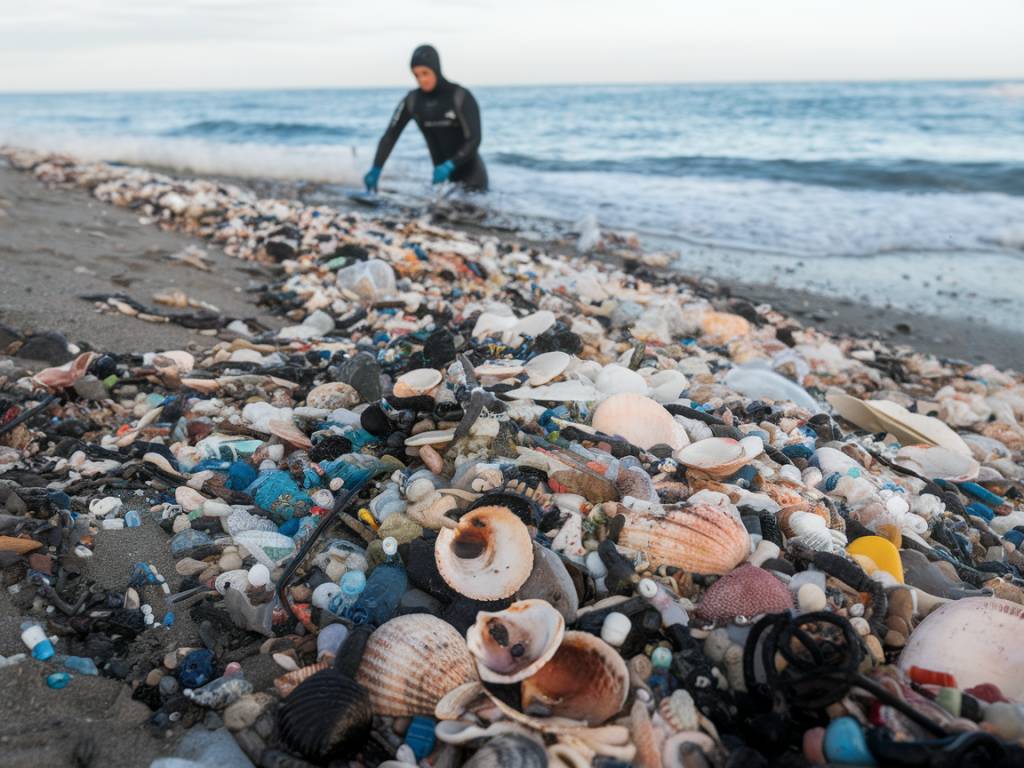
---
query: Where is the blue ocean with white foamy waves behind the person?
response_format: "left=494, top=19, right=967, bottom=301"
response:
left=0, top=82, right=1024, bottom=325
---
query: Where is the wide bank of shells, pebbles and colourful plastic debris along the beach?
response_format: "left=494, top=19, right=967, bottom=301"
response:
left=0, top=145, right=1024, bottom=768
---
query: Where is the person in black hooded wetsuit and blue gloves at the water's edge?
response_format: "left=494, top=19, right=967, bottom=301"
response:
left=362, top=45, right=487, bottom=191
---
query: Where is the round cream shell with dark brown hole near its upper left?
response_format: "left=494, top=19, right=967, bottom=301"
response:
left=434, top=507, right=534, bottom=600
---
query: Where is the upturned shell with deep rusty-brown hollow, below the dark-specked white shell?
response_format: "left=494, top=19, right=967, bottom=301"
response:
left=521, top=632, right=630, bottom=725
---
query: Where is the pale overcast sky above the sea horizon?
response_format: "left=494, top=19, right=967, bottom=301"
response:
left=0, top=0, right=1024, bottom=91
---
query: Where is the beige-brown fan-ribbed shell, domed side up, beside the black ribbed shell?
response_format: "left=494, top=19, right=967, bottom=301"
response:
left=355, top=613, right=476, bottom=717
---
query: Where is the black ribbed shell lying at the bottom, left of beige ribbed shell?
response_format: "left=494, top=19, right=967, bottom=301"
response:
left=278, top=669, right=374, bottom=763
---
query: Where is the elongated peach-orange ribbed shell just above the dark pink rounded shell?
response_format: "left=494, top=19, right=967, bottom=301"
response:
left=618, top=504, right=751, bottom=573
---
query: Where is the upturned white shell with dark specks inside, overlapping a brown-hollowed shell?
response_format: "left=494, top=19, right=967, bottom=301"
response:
left=466, top=600, right=565, bottom=683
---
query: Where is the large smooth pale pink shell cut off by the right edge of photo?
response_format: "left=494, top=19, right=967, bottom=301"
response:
left=899, top=597, right=1024, bottom=700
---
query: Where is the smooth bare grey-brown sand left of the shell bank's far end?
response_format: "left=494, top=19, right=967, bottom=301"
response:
left=0, top=161, right=284, bottom=352
